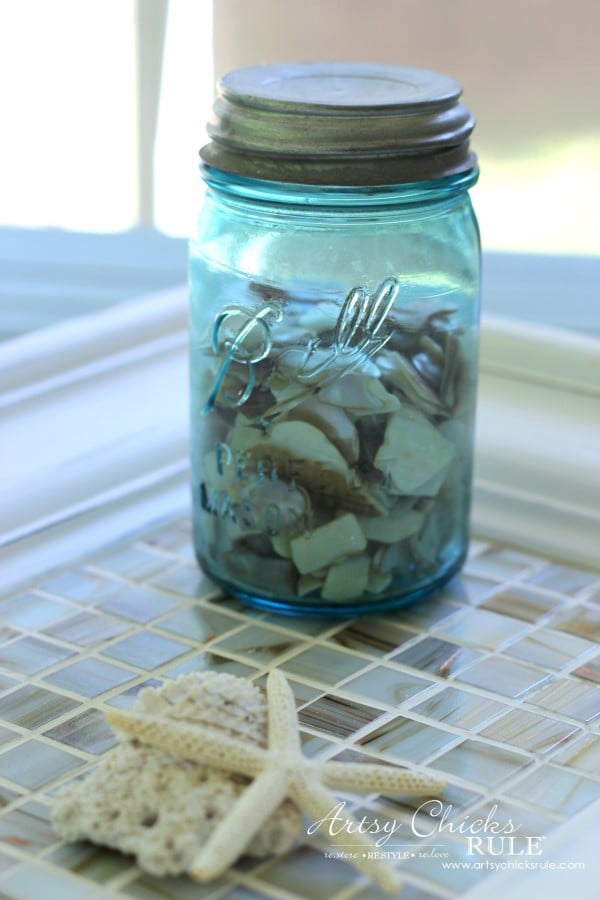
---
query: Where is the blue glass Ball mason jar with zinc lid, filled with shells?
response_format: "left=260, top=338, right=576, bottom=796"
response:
left=190, top=63, right=480, bottom=616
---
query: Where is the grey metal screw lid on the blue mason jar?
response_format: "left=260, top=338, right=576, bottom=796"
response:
left=200, top=62, right=476, bottom=186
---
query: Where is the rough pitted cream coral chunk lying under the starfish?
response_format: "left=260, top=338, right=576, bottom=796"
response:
left=53, top=672, right=302, bottom=875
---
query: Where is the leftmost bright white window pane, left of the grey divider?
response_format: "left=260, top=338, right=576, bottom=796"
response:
left=0, top=0, right=137, bottom=231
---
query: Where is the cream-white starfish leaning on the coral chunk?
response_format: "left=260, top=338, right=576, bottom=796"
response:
left=106, top=669, right=444, bottom=893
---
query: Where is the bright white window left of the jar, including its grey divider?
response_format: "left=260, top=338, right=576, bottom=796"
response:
left=0, top=0, right=213, bottom=235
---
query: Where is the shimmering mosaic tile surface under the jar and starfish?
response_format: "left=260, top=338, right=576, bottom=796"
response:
left=0, top=520, right=600, bottom=900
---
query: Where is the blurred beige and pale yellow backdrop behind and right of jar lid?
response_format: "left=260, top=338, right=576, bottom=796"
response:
left=214, top=0, right=600, bottom=253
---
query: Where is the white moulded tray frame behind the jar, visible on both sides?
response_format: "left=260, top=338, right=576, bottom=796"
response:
left=0, top=264, right=600, bottom=589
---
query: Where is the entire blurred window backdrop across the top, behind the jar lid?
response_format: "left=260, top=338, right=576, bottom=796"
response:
left=0, top=0, right=600, bottom=254
